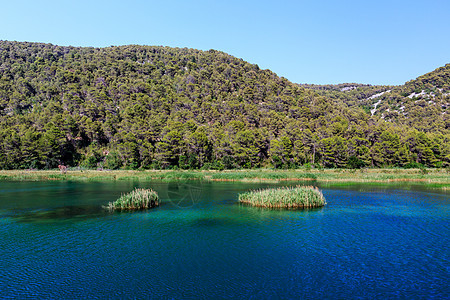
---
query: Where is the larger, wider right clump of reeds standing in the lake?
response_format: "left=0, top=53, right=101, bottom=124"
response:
left=239, top=186, right=326, bottom=209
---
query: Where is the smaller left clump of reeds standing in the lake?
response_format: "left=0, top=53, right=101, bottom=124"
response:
left=107, top=188, right=160, bottom=210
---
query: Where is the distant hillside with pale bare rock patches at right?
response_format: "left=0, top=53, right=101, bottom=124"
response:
left=301, top=64, right=450, bottom=132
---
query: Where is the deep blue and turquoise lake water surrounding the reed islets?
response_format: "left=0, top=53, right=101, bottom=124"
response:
left=0, top=181, right=450, bottom=299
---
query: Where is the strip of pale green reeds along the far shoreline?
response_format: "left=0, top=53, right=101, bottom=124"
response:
left=0, top=169, right=450, bottom=189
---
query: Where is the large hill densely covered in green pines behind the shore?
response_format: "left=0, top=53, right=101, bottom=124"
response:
left=0, top=41, right=450, bottom=169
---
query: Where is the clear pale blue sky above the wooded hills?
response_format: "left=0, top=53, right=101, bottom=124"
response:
left=0, top=0, right=450, bottom=84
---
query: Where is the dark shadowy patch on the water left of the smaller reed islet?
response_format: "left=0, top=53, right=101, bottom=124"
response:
left=0, top=205, right=111, bottom=223
